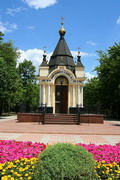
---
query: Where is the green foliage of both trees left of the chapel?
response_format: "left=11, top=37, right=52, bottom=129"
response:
left=0, top=32, right=39, bottom=114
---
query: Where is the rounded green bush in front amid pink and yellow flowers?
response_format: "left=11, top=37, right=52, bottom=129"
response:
left=34, top=143, right=97, bottom=180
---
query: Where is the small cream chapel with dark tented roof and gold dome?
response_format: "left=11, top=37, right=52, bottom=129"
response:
left=38, top=22, right=86, bottom=114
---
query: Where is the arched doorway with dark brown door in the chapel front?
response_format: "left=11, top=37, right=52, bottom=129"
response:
left=55, top=76, right=68, bottom=113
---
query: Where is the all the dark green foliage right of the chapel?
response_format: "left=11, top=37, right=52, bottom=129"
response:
left=84, top=43, right=120, bottom=117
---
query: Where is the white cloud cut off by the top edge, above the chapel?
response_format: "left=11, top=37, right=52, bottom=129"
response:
left=22, top=0, right=57, bottom=9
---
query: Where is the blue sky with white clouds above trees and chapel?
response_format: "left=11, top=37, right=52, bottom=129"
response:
left=0, top=0, right=120, bottom=78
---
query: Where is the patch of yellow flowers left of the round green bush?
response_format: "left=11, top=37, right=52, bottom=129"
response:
left=0, top=158, right=38, bottom=180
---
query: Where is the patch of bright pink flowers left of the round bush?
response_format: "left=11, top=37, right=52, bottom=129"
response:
left=0, top=140, right=46, bottom=163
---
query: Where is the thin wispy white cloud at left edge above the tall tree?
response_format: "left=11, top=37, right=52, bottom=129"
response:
left=0, top=21, right=17, bottom=33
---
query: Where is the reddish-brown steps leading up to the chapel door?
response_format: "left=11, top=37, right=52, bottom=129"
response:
left=44, top=114, right=77, bottom=125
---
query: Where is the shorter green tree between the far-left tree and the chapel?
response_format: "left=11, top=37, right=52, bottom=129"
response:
left=18, top=59, right=39, bottom=112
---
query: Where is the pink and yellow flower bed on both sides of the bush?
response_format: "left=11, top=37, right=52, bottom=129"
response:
left=0, top=140, right=120, bottom=180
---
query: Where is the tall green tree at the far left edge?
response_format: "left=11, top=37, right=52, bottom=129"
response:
left=0, top=33, right=22, bottom=114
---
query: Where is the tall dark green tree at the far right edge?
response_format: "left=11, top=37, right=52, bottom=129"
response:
left=95, top=43, right=120, bottom=117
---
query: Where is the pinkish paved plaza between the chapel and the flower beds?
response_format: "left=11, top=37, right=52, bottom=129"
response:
left=0, top=116, right=120, bottom=145
